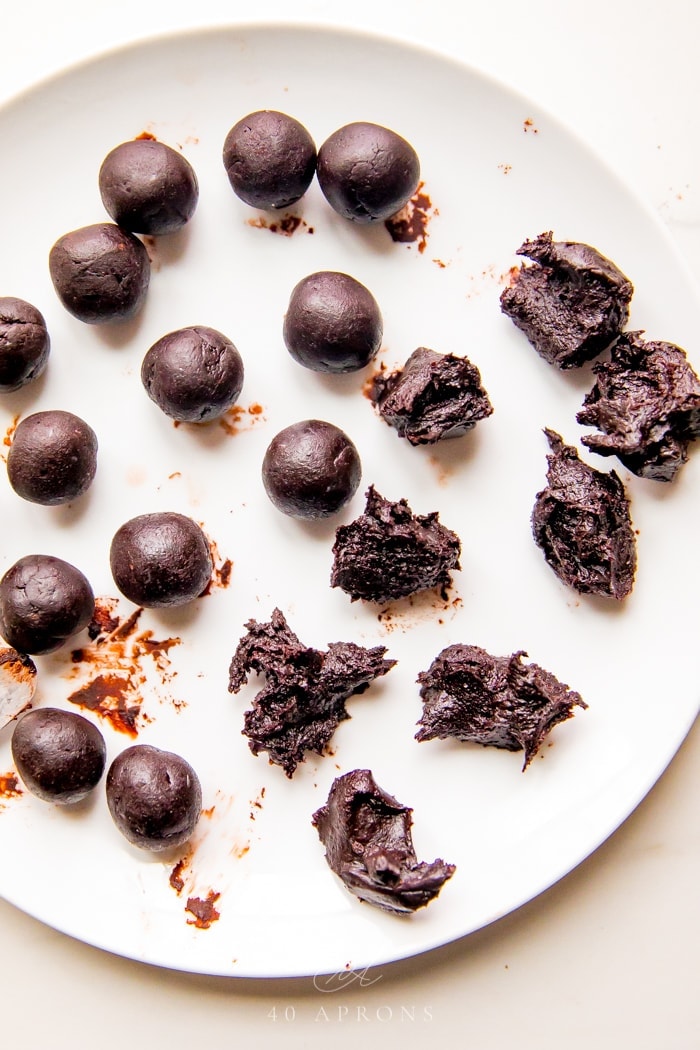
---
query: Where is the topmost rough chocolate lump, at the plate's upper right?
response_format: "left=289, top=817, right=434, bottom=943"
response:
left=501, top=233, right=634, bottom=369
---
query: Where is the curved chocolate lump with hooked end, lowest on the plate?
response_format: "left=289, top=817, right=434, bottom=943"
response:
left=312, top=770, right=454, bottom=915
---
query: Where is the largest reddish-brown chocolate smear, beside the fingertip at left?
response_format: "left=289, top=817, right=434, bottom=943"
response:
left=68, top=597, right=186, bottom=737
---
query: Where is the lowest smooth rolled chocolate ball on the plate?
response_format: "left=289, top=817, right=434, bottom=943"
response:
left=106, top=743, right=201, bottom=853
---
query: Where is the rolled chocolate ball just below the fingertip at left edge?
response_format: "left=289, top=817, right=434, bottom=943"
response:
left=12, top=708, right=107, bottom=805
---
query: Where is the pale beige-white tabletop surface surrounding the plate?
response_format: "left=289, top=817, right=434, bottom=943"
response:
left=0, top=0, right=700, bottom=1050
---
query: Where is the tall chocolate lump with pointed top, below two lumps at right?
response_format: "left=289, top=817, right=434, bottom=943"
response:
left=532, top=431, right=637, bottom=600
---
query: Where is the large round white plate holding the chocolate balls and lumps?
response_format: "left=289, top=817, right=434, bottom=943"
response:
left=0, top=27, right=700, bottom=977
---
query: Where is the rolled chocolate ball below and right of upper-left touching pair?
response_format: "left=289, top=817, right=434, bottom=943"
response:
left=141, top=326, right=243, bottom=423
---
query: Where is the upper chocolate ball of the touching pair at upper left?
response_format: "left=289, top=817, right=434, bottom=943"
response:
left=98, top=139, right=199, bottom=235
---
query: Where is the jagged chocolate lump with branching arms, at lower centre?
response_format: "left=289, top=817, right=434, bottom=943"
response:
left=229, top=609, right=396, bottom=777
